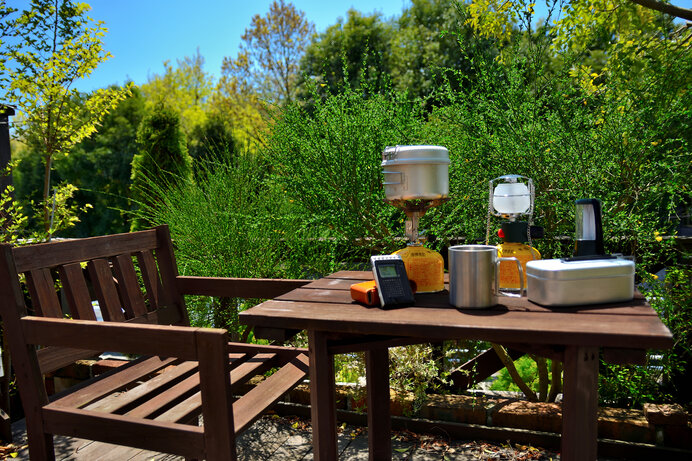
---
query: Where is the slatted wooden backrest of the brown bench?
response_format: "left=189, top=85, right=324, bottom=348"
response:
left=0, top=226, right=189, bottom=374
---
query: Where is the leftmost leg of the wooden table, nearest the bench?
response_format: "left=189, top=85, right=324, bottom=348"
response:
left=308, top=330, right=338, bottom=461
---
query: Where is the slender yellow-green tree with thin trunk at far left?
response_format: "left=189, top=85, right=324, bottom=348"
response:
left=3, top=0, right=129, bottom=233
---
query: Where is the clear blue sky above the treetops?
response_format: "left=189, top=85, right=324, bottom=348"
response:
left=7, top=0, right=692, bottom=91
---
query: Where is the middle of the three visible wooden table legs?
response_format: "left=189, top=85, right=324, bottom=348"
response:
left=365, top=347, right=392, bottom=461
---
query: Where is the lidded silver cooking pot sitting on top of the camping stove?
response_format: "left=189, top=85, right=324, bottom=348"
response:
left=382, top=146, right=449, bottom=200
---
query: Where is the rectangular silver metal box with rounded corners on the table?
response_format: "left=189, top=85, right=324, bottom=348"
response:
left=526, top=258, right=634, bottom=306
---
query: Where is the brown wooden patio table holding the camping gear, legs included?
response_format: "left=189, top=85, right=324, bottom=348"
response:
left=240, top=271, right=673, bottom=461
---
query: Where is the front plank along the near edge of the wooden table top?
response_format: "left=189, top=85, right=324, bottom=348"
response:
left=240, top=301, right=672, bottom=349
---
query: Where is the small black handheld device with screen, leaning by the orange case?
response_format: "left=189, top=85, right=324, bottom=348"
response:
left=370, top=255, right=415, bottom=309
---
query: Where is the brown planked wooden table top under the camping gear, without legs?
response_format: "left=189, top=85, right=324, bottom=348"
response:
left=240, top=271, right=673, bottom=349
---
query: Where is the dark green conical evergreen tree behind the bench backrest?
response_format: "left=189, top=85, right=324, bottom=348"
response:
left=131, top=107, right=192, bottom=231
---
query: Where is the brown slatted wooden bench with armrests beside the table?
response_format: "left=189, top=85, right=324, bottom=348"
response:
left=0, top=226, right=309, bottom=460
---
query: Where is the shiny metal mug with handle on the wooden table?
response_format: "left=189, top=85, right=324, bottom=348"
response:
left=448, top=245, right=526, bottom=309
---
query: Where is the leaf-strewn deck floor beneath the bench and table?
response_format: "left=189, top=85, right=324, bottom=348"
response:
left=12, top=416, right=560, bottom=461
